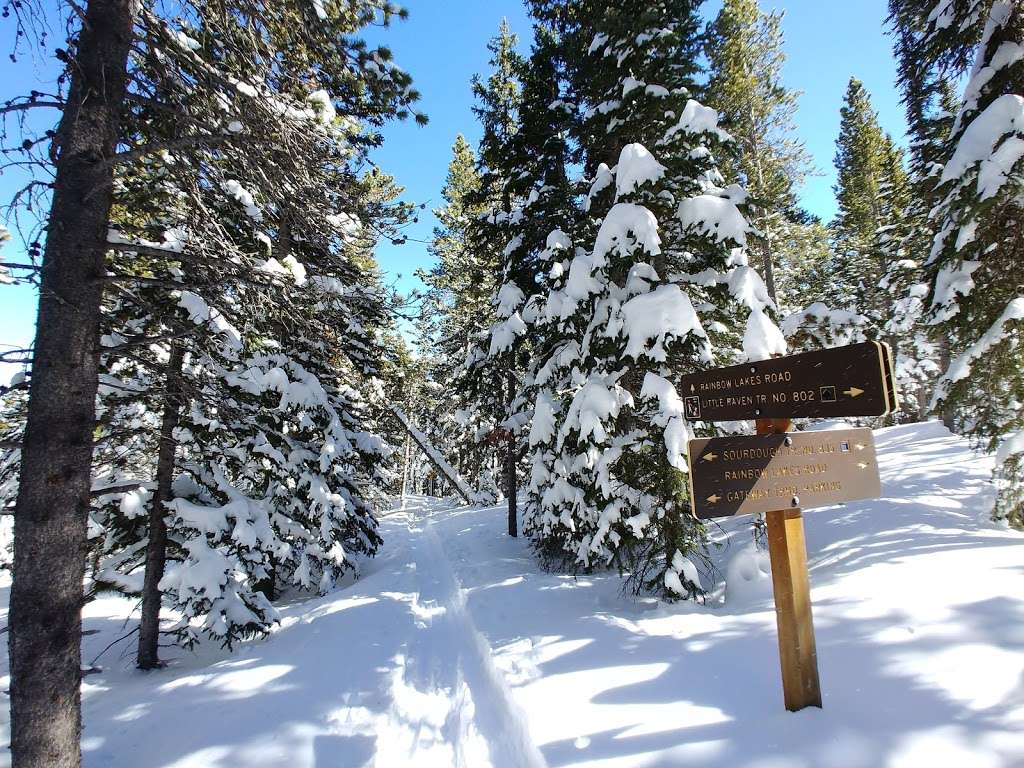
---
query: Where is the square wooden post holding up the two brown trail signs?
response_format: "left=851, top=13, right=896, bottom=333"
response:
left=757, top=419, right=821, bottom=712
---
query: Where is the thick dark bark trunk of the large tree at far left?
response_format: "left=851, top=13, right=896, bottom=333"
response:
left=9, top=0, right=137, bottom=768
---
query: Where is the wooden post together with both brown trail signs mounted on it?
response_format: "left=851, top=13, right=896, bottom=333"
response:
left=677, top=342, right=899, bottom=712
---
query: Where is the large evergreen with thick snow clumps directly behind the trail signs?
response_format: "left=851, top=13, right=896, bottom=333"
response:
left=526, top=2, right=784, bottom=596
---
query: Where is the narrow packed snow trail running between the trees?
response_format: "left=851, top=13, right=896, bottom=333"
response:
left=376, top=511, right=547, bottom=768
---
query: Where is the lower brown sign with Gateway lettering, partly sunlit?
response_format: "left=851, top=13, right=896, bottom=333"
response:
left=688, top=429, right=882, bottom=519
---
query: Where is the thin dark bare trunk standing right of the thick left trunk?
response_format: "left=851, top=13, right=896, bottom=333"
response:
left=136, top=341, right=184, bottom=670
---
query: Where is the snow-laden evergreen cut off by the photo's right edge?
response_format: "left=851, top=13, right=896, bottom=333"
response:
left=898, top=0, right=1024, bottom=525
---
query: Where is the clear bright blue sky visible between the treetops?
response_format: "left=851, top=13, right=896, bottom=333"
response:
left=0, top=0, right=904, bottom=378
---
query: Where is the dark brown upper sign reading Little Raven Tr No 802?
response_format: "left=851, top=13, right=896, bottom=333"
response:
left=676, top=341, right=899, bottom=421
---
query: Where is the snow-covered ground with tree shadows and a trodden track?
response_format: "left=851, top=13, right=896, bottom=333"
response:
left=0, top=423, right=1024, bottom=768
